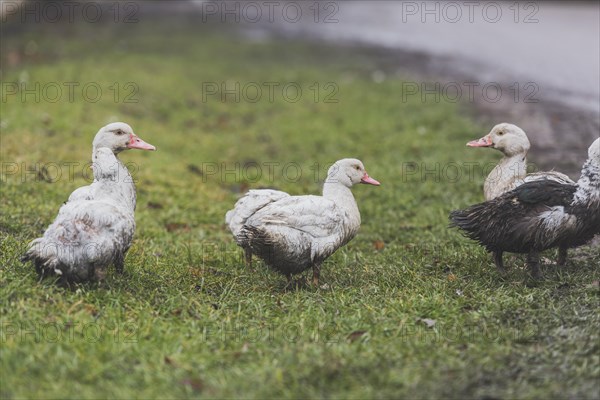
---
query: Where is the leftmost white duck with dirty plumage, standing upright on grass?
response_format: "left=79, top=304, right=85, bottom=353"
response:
left=23, top=124, right=154, bottom=281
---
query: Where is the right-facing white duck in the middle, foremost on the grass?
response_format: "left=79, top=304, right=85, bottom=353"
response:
left=230, top=158, right=379, bottom=285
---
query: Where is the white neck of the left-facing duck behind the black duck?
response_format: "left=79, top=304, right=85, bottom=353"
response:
left=484, top=153, right=527, bottom=200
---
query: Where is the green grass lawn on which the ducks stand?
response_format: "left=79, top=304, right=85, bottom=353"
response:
left=0, top=17, right=600, bottom=399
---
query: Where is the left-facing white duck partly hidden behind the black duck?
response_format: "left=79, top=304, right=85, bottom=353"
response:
left=467, top=123, right=575, bottom=201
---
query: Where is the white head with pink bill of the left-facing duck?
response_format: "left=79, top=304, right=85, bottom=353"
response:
left=467, top=123, right=530, bottom=157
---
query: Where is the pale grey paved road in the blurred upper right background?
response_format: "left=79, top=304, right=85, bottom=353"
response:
left=260, top=1, right=600, bottom=112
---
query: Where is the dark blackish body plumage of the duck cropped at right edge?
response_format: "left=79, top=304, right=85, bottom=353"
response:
left=450, top=180, right=600, bottom=253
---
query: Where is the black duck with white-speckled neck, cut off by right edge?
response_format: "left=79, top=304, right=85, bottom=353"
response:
left=450, top=139, right=600, bottom=275
